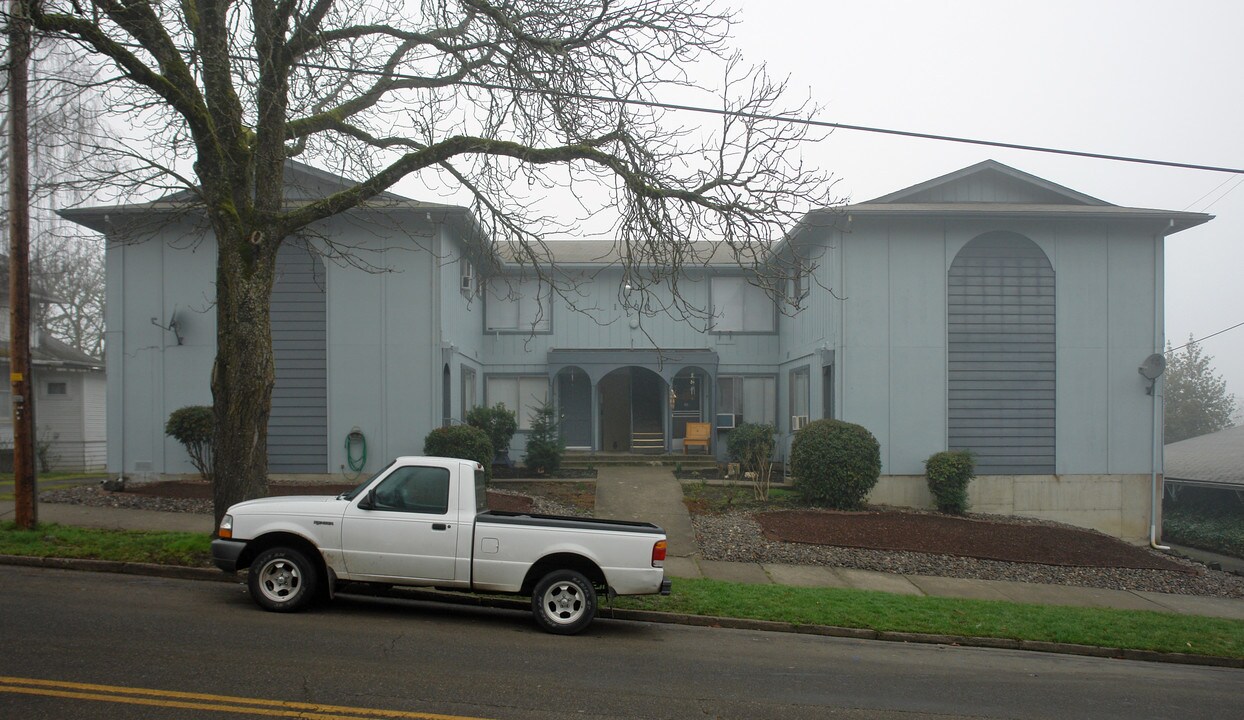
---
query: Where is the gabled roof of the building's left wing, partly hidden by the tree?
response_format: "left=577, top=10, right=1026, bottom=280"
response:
left=60, top=160, right=469, bottom=233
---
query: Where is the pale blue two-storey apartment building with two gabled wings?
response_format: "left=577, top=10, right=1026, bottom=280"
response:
left=65, top=162, right=1210, bottom=541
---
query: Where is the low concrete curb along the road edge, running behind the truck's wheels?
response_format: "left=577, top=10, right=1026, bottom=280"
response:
left=0, top=555, right=1244, bottom=669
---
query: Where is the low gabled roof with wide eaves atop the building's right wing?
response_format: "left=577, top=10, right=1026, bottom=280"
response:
left=790, top=160, right=1213, bottom=239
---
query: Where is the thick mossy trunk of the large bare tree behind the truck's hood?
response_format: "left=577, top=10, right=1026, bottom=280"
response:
left=211, top=230, right=276, bottom=525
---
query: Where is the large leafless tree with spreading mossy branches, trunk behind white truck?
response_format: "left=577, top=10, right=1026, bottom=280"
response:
left=32, top=0, right=832, bottom=519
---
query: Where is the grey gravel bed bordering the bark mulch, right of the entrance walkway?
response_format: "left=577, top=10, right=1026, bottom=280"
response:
left=692, top=512, right=1244, bottom=598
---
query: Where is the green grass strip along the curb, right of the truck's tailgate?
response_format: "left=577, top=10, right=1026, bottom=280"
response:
left=615, top=579, right=1244, bottom=658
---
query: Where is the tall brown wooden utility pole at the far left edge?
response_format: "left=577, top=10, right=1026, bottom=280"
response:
left=9, top=0, right=39, bottom=530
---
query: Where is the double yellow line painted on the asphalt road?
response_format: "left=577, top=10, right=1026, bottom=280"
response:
left=0, top=675, right=495, bottom=720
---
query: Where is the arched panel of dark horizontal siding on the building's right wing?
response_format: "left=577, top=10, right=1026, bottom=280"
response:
left=947, top=233, right=1055, bottom=475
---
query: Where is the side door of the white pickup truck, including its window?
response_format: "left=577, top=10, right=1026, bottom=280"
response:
left=341, top=465, right=460, bottom=581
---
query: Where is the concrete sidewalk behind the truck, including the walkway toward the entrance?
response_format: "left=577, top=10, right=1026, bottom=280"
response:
left=7, top=466, right=1244, bottom=619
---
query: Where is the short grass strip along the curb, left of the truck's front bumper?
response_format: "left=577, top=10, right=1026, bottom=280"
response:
left=0, top=522, right=211, bottom=567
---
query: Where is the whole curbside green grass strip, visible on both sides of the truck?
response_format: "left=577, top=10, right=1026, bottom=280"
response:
left=0, top=522, right=1244, bottom=658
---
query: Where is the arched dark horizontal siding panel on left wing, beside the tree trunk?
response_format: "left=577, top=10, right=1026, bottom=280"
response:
left=267, top=241, right=328, bottom=473
